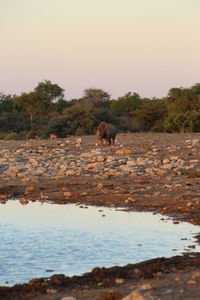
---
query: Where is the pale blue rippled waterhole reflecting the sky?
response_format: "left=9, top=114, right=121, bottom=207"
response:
left=0, top=200, right=200, bottom=285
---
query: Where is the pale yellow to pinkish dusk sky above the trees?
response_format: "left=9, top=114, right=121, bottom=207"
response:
left=0, top=0, right=200, bottom=99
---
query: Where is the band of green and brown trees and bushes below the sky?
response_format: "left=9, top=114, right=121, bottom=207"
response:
left=0, top=80, right=200, bottom=140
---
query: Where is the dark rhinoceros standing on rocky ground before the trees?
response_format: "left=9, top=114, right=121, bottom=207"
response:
left=96, top=122, right=117, bottom=145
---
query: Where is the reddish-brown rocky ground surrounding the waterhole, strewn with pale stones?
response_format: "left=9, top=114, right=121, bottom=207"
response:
left=0, top=133, right=200, bottom=300
